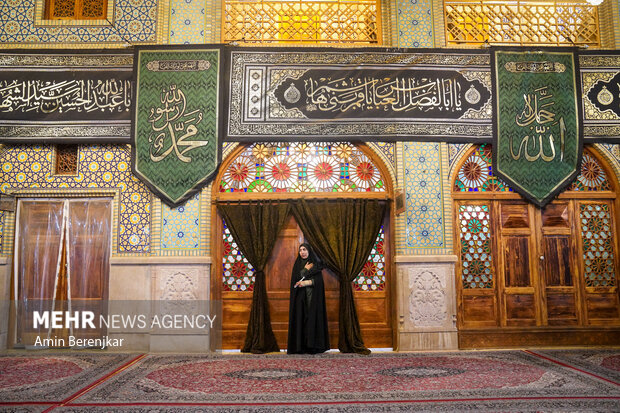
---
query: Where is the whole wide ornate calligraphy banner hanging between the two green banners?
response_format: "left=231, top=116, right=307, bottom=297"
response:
left=226, top=48, right=492, bottom=141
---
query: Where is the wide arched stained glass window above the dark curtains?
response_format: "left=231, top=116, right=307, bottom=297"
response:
left=220, top=142, right=385, bottom=192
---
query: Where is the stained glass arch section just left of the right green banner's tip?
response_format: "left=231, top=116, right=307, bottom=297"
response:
left=454, top=144, right=512, bottom=192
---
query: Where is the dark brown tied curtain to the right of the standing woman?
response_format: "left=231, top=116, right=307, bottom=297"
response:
left=292, top=199, right=387, bottom=354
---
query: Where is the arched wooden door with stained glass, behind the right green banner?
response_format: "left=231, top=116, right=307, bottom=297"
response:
left=452, top=145, right=620, bottom=348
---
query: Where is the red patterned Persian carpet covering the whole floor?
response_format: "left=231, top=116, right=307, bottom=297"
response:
left=0, top=349, right=620, bottom=413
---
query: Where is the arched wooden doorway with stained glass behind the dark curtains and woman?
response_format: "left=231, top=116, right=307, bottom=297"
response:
left=211, top=142, right=394, bottom=349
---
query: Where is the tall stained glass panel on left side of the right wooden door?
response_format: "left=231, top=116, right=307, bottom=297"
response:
left=459, top=205, right=493, bottom=288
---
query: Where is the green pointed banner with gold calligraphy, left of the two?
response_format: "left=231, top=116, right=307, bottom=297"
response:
left=132, top=46, right=223, bottom=206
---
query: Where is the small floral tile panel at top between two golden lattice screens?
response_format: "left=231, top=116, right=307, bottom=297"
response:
left=397, top=0, right=434, bottom=47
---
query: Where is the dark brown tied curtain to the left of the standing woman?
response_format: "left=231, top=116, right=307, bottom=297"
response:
left=218, top=202, right=291, bottom=354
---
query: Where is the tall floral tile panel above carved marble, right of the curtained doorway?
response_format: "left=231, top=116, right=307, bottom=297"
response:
left=401, top=142, right=447, bottom=248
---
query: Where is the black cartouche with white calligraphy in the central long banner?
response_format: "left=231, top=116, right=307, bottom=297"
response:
left=274, top=69, right=490, bottom=119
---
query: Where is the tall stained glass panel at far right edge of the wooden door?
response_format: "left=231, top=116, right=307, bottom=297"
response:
left=579, top=203, right=616, bottom=287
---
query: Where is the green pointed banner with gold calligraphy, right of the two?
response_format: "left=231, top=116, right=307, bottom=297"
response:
left=491, top=48, right=583, bottom=207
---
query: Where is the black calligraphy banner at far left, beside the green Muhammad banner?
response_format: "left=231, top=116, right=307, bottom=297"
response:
left=0, top=50, right=133, bottom=143
